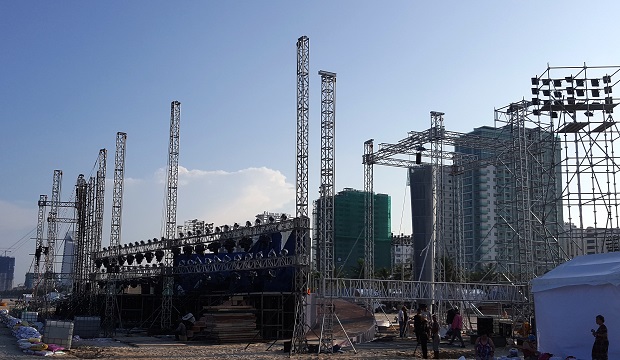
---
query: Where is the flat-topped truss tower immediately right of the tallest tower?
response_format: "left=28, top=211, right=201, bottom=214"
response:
left=318, top=71, right=336, bottom=352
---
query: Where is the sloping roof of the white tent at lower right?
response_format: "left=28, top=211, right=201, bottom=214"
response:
left=531, top=252, right=620, bottom=293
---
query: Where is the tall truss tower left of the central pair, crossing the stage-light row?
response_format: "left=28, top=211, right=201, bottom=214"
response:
left=161, top=101, right=181, bottom=329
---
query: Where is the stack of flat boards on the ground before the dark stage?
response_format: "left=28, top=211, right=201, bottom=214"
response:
left=191, top=307, right=261, bottom=344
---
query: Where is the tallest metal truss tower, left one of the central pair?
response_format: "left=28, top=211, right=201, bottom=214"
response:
left=290, top=36, right=310, bottom=355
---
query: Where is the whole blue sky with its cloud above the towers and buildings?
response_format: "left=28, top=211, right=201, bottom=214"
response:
left=0, top=1, right=620, bottom=285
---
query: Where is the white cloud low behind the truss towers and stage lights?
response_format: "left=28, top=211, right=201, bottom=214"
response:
left=111, top=166, right=295, bottom=244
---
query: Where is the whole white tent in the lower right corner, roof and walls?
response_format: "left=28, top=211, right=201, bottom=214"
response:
left=531, top=252, right=620, bottom=359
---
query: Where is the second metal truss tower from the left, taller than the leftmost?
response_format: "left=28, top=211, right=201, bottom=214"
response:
left=43, top=170, right=62, bottom=313
